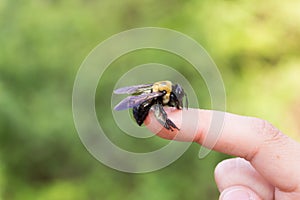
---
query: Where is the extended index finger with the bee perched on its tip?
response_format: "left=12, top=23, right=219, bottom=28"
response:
left=145, top=108, right=300, bottom=193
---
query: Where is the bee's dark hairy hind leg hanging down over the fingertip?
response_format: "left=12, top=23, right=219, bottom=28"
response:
left=152, top=104, right=179, bottom=131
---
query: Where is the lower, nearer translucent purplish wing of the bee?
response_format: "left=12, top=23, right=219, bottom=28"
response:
left=114, top=92, right=163, bottom=110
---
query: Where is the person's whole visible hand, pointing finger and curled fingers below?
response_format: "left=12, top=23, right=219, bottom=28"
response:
left=144, top=108, right=300, bottom=200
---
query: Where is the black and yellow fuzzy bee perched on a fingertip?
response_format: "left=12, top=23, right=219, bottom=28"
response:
left=114, top=81, right=188, bottom=131
